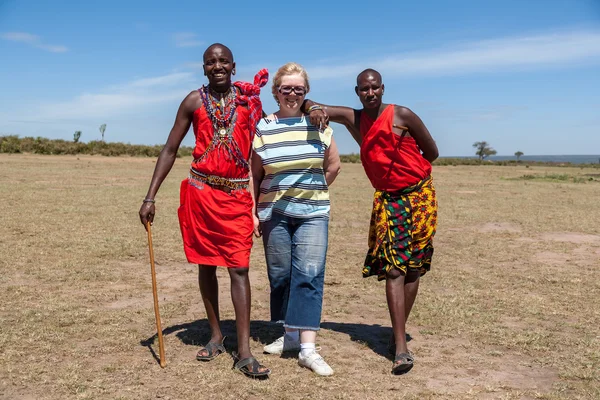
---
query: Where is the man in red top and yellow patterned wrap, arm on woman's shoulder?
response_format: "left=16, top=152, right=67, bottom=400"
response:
left=303, top=69, right=438, bottom=374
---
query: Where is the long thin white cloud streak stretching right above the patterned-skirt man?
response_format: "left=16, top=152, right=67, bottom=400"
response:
left=307, top=31, right=600, bottom=79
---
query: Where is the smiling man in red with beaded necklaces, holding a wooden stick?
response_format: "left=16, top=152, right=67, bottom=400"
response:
left=139, top=43, right=271, bottom=377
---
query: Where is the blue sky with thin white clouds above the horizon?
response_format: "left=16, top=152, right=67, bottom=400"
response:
left=0, top=0, right=600, bottom=156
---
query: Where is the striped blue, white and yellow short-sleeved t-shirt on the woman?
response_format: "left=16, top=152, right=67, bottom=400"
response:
left=253, top=117, right=333, bottom=222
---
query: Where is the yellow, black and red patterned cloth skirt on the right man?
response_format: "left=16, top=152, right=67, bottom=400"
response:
left=363, top=177, right=437, bottom=281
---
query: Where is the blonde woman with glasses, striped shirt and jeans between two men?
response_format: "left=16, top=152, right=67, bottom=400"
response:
left=252, top=63, right=340, bottom=376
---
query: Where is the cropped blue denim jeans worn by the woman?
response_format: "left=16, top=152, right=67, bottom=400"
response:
left=262, top=213, right=329, bottom=331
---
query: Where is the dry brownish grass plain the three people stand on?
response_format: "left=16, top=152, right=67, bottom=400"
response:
left=0, top=154, right=600, bottom=399
